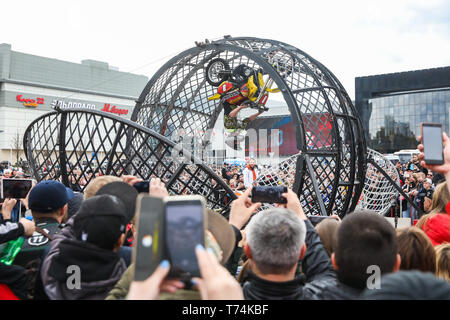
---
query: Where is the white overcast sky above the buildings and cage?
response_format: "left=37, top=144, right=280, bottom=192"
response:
left=0, top=0, right=450, bottom=99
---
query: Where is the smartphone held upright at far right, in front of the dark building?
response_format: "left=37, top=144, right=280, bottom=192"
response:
left=420, top=122, right=444, bottom=164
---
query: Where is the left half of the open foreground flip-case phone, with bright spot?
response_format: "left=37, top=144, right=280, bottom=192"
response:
left=133, top=194, right=166, bottom=281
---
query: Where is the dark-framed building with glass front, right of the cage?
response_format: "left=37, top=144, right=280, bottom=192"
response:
left=355, top=67, right=450, bottom=153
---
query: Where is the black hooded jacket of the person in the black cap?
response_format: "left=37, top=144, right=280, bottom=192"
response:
left=41, top=231, right=127, bottom=300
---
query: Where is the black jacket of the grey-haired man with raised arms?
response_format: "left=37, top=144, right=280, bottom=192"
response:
left=243, top=220, right=337, bottom=300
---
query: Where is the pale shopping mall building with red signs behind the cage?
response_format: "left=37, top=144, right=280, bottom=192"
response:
left=0, top=43, right=148, bottom=164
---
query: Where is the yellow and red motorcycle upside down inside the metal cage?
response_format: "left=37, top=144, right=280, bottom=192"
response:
left=206, top=58, right=280, bottom=111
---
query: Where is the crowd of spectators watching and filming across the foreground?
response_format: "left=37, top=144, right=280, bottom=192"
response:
left=0, top=136, right=450, bottom=300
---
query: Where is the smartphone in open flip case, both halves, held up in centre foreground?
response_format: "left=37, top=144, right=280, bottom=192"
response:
left=133, top=194, right=207, bottom=281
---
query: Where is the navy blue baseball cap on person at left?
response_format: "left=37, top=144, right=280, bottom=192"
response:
left=28, top=180, right=74, bottom=213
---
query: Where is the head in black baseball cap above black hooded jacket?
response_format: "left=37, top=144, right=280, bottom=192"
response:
left=73, top=194, right=127, bottom=250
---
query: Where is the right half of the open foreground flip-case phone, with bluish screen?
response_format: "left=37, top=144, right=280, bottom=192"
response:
left=165, top=195, right=207, bottom=279
